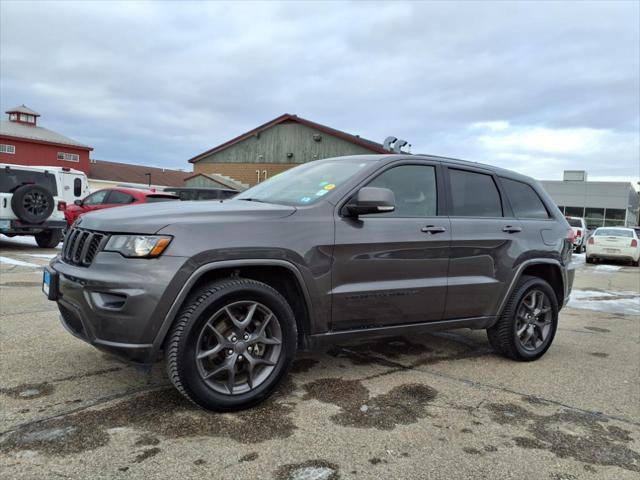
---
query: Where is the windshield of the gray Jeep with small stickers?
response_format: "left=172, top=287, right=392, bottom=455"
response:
left=235, top=160, right=372, bottom=206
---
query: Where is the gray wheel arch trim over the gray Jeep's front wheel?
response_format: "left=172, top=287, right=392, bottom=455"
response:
left=153, top=259, right=312, bottom=354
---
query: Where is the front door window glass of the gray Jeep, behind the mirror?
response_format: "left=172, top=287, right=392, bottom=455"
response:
left=367, top=165, right=438, bottom=217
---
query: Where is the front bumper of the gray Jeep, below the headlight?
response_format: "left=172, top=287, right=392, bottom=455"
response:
left=48, top=252, right=186, bottom=364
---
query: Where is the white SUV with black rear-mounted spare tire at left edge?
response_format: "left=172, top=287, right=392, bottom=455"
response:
left=0, top=163, right=89, bottom=248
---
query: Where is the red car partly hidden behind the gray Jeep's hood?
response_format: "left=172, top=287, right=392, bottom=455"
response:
left=64, top=187, right=180, bottom=225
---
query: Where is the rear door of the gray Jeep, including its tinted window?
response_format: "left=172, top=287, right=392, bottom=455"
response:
left=444, top=166, right=527, bottom=319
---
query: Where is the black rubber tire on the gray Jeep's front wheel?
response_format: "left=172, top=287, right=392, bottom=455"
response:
left=165, top=278, right=297, bottom=411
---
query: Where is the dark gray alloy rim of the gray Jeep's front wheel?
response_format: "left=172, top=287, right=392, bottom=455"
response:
left=195, top=301, right=282, bottom=395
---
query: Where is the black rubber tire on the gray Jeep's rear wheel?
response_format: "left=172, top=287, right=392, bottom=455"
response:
left=487, top=276, right=558, bottom=362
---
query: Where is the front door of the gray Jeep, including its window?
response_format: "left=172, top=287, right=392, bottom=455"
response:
left=331, top=162, right=451, bottom=330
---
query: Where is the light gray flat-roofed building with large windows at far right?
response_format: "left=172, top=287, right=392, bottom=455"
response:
left=541, top=170, right=640, bottom=229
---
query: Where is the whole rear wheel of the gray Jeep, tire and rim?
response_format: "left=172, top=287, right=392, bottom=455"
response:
left=487, top=276, right=558, bottom=361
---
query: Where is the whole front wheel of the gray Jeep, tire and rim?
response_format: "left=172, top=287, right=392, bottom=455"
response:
left=165, top=279, right=297, bottom=411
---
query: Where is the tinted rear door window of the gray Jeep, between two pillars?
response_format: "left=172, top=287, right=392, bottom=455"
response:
left=449, top=168, right=502, bottom=217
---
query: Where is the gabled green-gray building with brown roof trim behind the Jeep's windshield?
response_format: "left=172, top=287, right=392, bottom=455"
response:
left=185, top=113, right=388, bottom=187
